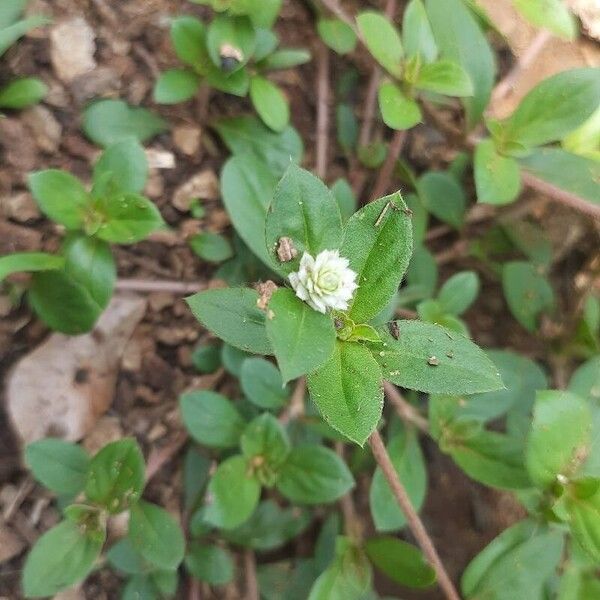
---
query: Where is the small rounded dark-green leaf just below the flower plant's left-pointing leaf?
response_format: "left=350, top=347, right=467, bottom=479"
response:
left=240, top=358, right=290, bottom=410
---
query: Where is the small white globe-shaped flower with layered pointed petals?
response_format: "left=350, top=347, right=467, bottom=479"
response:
left=289, top=250, right=358, bottom=313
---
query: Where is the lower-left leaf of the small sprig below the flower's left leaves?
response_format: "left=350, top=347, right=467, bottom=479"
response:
left=204, top=455, right=260, bottom=529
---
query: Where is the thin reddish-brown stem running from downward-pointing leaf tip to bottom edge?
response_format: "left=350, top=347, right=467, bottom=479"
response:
left=369, top=430, right=460, bottom=600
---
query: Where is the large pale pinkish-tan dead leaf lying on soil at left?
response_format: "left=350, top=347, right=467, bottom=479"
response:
left=6, top=296, right=146, bottom=443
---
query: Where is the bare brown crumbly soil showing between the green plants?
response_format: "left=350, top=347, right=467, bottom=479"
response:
left=0, top=0, right=598, bottom=600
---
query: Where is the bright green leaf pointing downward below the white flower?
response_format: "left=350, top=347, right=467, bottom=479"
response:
left=308, top=342, right=383, bottom=446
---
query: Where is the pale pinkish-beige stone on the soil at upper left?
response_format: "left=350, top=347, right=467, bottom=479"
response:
left=50, top=17, right=96, bottom=83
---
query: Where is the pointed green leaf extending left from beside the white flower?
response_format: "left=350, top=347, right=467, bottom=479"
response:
left=186, top=288, right=272, bottom=354
